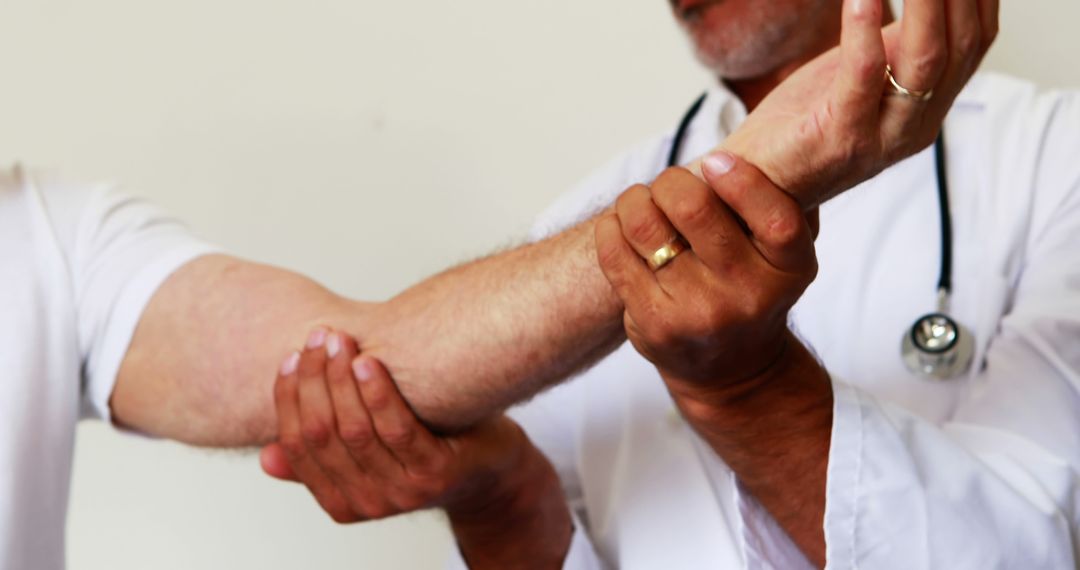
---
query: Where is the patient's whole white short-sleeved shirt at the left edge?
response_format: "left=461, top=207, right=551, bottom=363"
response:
left=0, top=167, right=211, bottom=570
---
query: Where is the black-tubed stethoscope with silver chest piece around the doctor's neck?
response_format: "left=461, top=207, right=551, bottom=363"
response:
left=667, top=94, right=975, bottom=380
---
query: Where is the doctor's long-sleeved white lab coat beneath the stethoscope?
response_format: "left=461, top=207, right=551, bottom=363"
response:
left=447, top=76, right=1080, bottom=570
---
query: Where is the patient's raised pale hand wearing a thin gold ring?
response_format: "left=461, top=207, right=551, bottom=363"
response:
left=704, top=0, right=999, bottom=208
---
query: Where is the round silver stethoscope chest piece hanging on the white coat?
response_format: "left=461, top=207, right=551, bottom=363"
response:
left=901, top=313, right=975, bottom=380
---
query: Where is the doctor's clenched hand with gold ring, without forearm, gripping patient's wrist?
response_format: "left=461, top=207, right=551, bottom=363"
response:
left=596, top=152, right=818, bottom=390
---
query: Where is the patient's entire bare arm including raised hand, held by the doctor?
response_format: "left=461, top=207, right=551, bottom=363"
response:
left=111, top=0, right=997, bottom=446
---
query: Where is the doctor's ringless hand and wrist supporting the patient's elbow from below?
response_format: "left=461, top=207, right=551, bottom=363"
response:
left=260, top=328, right=572, bottom=568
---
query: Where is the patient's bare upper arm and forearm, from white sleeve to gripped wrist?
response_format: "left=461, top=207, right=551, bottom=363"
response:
left=111, top=215, right=623, bottom=447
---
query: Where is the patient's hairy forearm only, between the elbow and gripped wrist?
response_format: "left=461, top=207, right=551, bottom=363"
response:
left=356, top=215, right=624, bottom=430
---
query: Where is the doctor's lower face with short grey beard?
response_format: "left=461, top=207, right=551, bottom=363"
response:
left=672, top=0, right=831, bottom=80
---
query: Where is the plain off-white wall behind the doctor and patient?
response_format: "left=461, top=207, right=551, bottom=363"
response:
left=0, top=0, right=1080, bottom=570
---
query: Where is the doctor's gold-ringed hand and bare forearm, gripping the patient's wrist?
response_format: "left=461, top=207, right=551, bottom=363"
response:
left=596, top=154, right=833, bottom=566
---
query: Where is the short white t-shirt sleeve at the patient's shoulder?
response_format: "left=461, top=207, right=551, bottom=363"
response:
left=60, top=186, right=215, bottom=420
